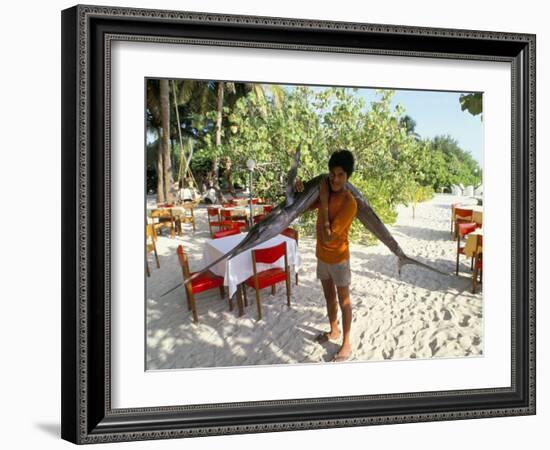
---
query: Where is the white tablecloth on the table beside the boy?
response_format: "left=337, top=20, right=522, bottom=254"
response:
left=202, top=233, right=302, bottom=296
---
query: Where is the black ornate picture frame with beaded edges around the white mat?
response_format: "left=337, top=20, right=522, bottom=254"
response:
left=61, top=5, right=536, bottom=444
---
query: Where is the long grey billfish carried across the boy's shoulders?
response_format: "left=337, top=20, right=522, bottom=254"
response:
left=162, top=150, right=447, bottom=295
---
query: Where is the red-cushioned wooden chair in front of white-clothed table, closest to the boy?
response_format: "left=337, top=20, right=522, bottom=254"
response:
left=243, top=242, right=290, bottom=320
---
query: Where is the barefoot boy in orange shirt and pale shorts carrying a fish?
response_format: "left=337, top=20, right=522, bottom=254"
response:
left=296, top=149, right=357, bottom=362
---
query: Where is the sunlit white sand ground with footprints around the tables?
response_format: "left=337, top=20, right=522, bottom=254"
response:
left=146, top=194, right=483, bottom=370
